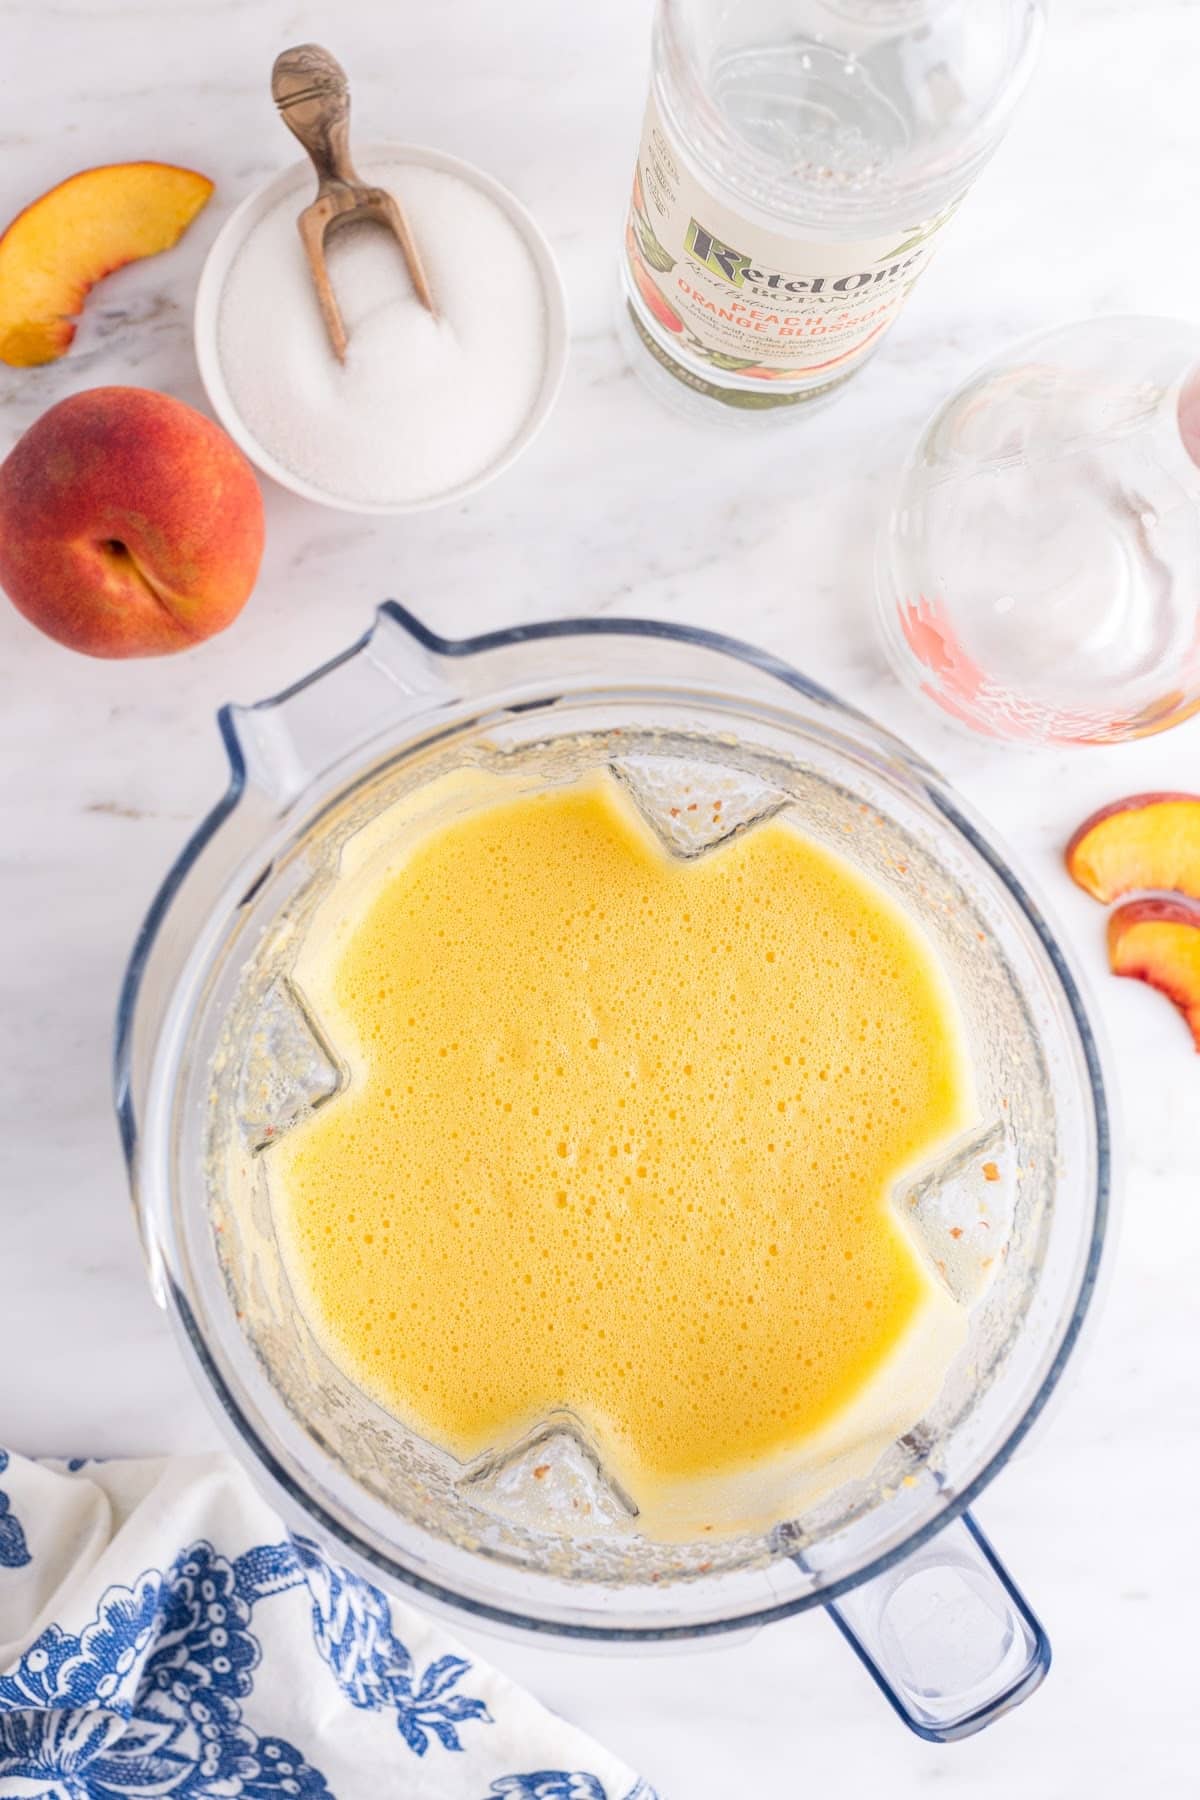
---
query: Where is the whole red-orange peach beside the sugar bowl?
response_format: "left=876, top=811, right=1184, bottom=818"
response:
left=0, top=387, right=263, bottom=657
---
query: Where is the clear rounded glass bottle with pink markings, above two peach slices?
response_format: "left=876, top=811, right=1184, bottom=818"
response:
left=876, top=317, right=1200, bottom=743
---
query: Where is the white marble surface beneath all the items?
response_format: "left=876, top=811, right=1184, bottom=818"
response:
left=0, top=0, right=1200, bottom=1800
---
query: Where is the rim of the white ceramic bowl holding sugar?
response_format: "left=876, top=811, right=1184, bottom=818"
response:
left=194, top=144, right=567, bottom=517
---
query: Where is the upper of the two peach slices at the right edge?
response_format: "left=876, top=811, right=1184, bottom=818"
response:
left=1067, top=794, right=1200, bottom=900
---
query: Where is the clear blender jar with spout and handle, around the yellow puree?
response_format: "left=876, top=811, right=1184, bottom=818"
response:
left=115, top=605, right=1108, bottom=1741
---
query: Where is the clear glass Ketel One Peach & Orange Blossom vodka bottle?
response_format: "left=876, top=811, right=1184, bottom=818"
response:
left=622, top=0, right=1043, bottom=410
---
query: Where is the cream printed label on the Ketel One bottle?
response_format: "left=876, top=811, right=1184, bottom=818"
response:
left=624, top=94, right=957, bottom=382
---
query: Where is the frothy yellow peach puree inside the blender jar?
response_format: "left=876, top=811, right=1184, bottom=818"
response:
left=270, top=776, right=970, bottom=1535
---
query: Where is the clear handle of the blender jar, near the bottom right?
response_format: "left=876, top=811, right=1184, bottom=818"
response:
left=826, top=1512, right=1051, bottom=1744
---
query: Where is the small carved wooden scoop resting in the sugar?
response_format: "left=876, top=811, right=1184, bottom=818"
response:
left=272, top=43, right=437, bottom=362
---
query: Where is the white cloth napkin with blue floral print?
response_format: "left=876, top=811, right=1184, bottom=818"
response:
left=0, top=1451, right=655, bottom=1800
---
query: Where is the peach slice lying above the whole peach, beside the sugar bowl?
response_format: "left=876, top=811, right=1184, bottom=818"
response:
left=0, top=162, right=212, bottom=369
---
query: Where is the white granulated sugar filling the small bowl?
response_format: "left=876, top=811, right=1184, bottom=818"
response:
left=218, top=162, right=547, bottom=506
